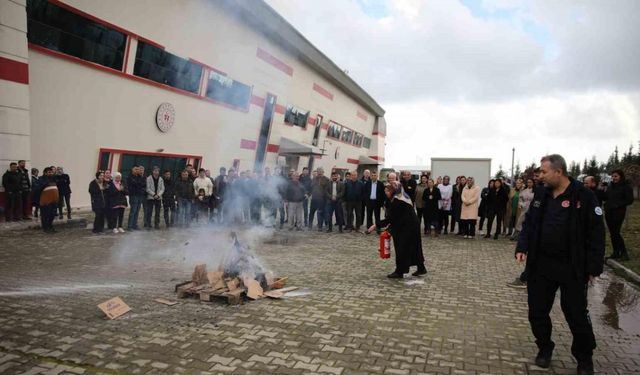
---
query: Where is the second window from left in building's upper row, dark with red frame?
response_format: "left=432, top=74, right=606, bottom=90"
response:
left=133, top=41, right=202, bottom=94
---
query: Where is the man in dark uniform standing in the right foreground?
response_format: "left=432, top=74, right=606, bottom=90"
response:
left=515, top=155, right=604, bottom=375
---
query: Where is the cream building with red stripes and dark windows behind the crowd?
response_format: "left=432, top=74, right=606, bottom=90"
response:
left=0, top=0, right=386, bottom=206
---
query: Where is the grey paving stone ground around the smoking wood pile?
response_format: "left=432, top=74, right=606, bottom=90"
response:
left=0, top=223, right=640, bottom=374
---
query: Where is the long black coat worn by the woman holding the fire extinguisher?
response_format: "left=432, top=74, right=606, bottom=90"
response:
left=380, top=199, right=424, bottom=273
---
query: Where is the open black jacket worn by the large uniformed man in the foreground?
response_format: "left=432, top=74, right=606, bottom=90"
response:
left=516, top=178, right=605, bottom=282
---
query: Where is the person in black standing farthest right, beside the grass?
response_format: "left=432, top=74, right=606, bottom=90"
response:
left=604, top=169, right=633, bottom=260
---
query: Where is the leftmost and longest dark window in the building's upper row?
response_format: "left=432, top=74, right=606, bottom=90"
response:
left=27, top=0, right=127, bottom=70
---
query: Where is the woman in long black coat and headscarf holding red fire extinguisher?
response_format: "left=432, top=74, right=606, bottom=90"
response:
left=367, top=181, right=427, bottom=279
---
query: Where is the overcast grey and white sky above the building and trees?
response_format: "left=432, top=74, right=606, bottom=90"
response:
left=267, top=0, right=640, bottom=173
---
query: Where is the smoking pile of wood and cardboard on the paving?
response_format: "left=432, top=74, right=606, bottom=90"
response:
left=175, top=232, right=297, bottom=305
